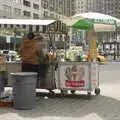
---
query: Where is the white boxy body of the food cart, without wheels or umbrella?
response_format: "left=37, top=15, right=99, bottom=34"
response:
left=56, top=62, right=99, bottom=91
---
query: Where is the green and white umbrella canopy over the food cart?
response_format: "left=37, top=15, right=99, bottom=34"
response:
left=62, top=12, right=120, bottom=32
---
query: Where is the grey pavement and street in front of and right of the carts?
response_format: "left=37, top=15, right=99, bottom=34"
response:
left=0, top=62, right=120, bottom=120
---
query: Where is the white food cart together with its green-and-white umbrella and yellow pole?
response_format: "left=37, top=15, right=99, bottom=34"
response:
left=57, top=13, right=120, bottom=96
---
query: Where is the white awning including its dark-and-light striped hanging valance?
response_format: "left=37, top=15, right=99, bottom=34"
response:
left=0, top=19, right=56, bottom=34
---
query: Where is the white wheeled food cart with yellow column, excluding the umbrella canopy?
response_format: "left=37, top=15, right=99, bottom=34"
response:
left=56, top=29, right=100, bottom=96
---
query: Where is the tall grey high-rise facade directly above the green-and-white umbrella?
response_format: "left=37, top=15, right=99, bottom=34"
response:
left=76, top=0, right=120, bottom=18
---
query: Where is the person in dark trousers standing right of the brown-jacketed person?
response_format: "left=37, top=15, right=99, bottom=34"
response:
left=36, top=35, right=49, bottom=89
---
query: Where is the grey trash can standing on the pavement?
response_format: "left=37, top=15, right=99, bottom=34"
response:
left=11, top=72, right=37, bottom=110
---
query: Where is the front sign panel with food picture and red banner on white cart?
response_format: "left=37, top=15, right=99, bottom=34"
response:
left=60, top=64, right=88, bottom=88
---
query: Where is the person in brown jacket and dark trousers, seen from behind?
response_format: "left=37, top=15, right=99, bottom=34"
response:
left=20, top=33, right=40, bottom=72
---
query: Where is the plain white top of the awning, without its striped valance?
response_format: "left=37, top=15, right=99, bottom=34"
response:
left=0, top=19, right=55, bottom=25
